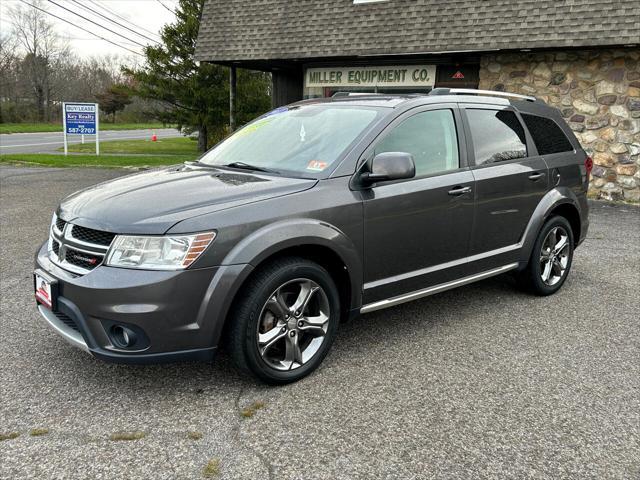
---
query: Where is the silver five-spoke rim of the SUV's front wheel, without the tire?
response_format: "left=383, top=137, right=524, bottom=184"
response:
left=257, top=278, right=331, bottom=370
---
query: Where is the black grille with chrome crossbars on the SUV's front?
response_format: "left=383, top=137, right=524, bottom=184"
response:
left=49, top=217, right=116, bottom=275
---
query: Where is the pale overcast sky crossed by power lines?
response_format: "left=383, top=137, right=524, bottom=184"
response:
left=0, top=0, right=178, bottom=62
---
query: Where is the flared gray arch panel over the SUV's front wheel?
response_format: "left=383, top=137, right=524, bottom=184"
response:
left=196, top=219, right=362, bottom=346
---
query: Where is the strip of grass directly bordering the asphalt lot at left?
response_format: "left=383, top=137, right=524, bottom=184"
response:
left=0, top=153, right=195, bottom=168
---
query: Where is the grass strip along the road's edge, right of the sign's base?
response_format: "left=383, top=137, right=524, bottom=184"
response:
left=64, top=137, right=198, bottom=159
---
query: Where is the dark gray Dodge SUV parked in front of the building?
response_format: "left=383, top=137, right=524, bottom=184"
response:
left=34, top=89, right=592, bottom=384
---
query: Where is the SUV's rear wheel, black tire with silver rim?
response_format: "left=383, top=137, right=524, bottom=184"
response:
left=517, top=215, right=574, bottom=296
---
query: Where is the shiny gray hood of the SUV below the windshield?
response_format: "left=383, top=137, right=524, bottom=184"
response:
left=58, top=165, right=317, bottom=235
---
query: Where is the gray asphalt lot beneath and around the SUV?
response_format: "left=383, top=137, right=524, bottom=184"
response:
left=0, top=168, right=640, bottom=480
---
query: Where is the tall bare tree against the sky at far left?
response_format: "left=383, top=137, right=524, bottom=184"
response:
left=9, top=0, right=69, bottom=121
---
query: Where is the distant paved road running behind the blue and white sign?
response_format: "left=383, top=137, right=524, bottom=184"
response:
left=0, top=128, right=182, bottom=154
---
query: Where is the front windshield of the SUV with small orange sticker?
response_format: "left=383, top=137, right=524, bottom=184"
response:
left=199, top=104, right=382, bottom=177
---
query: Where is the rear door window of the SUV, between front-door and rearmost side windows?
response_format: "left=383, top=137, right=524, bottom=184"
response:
left=467, top=109, right=527, bottom=165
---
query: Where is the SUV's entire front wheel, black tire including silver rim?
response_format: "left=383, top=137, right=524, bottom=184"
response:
left=227, top=257, right=340, bottom=385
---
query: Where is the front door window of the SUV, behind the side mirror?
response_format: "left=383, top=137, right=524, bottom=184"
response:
left=376, top=110, right=459, bottom=177
